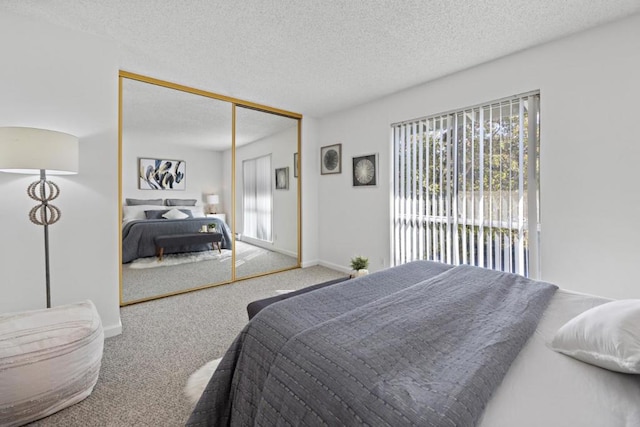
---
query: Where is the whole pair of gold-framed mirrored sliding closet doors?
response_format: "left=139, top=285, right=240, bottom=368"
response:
left=119, top=72, right=301, bottom=305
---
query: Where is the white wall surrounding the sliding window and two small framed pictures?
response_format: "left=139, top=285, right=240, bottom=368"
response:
left=316, top=15, right=640, bottom=298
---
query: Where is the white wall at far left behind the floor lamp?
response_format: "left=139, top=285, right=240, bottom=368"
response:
left=0, top=12, right=121, bottom=335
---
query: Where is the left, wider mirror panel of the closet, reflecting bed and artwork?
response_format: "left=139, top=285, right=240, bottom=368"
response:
left=122, top=79, right=232, bottom=303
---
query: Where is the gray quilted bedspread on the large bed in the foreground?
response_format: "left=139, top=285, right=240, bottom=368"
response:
left=187, top=261, right=557, bottom=426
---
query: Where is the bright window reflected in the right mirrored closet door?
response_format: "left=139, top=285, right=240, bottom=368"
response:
left=242, top=155, right=273, bottom=242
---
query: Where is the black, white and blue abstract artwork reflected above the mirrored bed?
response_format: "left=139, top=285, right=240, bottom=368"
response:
left=138, top=158, right=187, bottom=190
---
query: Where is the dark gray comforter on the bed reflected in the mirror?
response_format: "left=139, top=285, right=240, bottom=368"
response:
left=122, top=217, right=231, bottom=264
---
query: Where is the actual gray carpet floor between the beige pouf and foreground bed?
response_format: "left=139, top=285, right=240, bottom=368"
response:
left=30, top=267, right=344, bottom=427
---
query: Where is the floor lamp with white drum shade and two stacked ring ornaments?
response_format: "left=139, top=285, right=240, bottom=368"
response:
left=0, top=127, right=78, bottom=308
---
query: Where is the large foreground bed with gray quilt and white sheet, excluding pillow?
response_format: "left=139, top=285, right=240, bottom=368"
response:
left=187, top=261, right=640, bottom=427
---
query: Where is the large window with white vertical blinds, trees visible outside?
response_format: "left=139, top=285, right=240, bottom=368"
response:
left=392, top=92, right=540, bottom=277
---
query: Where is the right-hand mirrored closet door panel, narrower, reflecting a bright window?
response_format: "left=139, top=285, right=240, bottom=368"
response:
left=235, top=106, right=298, bottom=278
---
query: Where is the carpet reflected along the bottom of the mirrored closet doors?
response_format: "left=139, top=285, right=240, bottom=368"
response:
left=122, top=241, right=298, bottom=302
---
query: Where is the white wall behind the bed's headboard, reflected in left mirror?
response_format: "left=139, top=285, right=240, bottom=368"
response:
left=122, top=134, right=225, bottom=213
